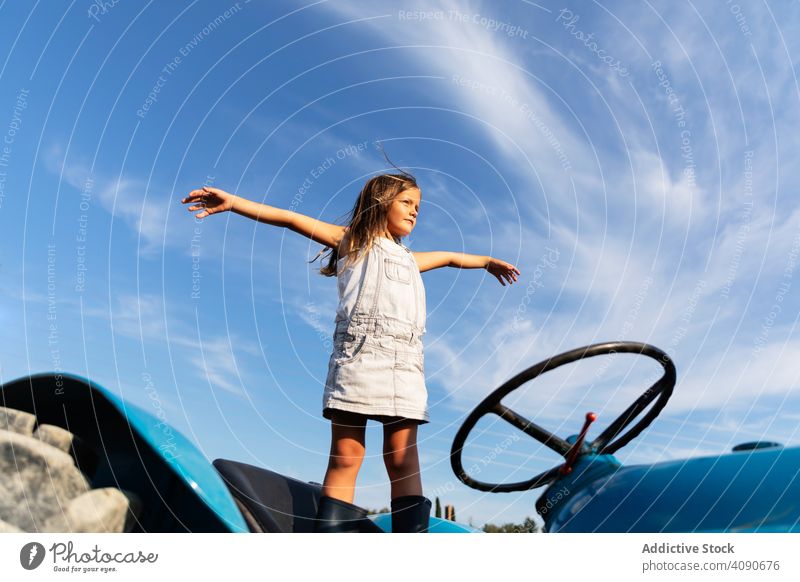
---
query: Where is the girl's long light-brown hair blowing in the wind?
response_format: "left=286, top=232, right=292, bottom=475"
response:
left=311, top=171, right=418, bottom=277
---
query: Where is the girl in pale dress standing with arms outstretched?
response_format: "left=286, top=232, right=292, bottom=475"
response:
left=182, top=171, right=520, bottom=532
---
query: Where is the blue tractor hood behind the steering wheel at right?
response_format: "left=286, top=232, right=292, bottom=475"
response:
left=536, top=444, right=800, bottom=533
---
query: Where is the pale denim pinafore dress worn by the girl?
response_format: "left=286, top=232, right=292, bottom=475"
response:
left=322, top=237, right=429, bottom=424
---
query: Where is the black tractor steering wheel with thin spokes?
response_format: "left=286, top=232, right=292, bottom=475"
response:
left=450, top=342, right=675, bottom=493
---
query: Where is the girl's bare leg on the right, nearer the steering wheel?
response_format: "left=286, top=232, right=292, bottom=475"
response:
left=383, top=420, right=422, bottom=499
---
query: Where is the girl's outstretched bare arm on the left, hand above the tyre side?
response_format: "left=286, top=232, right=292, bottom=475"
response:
left=181, top=186, right=345, bottom=248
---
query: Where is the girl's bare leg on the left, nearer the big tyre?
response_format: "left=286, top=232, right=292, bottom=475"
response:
left=322, top=410, right=367, bottom=503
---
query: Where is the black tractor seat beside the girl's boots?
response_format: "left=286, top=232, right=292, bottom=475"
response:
left=214, top=459, right=383, bottom=533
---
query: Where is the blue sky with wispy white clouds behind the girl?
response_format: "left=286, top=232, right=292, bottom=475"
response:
left=0, top=0, right=800, bottom=525
